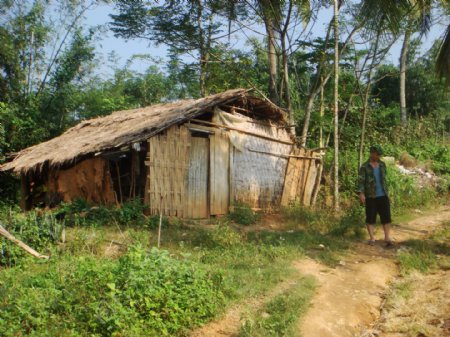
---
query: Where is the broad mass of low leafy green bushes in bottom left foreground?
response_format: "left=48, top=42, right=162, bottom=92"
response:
left=0, top=247, right=224, bottom=336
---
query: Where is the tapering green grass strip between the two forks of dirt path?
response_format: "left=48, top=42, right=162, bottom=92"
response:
left=239, top=277, right=315, bottom=337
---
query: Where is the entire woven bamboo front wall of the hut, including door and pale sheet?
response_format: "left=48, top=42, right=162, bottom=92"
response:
left=146, top=114, right=320, bottom=218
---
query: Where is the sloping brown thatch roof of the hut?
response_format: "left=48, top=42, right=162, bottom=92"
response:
left=0, top=89, right=285, bottom=174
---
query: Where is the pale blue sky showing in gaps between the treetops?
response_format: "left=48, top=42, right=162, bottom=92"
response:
left=86, top=5, right=448, bottom=76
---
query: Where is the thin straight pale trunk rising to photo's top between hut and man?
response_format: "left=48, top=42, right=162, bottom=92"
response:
left=333, top=0, right=339, bottom=212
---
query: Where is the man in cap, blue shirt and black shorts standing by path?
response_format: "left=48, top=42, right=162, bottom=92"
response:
left=358, top=145, right=393, bottom=247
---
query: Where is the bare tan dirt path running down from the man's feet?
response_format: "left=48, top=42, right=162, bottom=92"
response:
left=296, top=207, right=450, bottom=337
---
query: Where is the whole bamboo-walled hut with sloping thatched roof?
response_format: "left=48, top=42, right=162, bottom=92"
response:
left=0, top=89, right=320, bottom=218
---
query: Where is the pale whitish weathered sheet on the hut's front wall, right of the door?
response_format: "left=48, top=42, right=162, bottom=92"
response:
left=215, top=112, right=292, bottom=210
